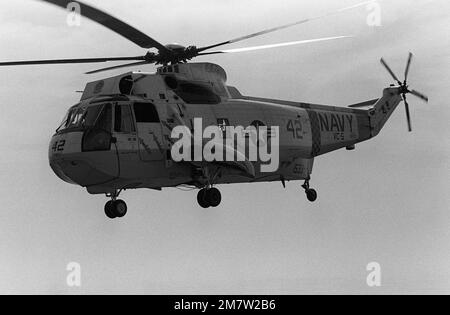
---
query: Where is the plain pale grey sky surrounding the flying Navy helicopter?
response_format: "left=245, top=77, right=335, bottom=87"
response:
left=0, top=0, right=450, bottom=294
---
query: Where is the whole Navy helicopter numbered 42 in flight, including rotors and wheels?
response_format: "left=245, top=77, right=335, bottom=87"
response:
left=0, top=0, right=428, bottom=219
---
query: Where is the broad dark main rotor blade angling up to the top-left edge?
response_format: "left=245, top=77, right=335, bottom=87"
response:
left=40, top=0, right=171, bottom=53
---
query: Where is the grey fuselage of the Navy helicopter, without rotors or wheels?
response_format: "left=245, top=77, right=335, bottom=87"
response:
left=49, top=63, right=399, bottom=194
